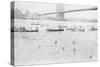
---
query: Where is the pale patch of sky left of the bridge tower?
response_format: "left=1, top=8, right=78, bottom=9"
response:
left=15, top=1, right=56, bottom=13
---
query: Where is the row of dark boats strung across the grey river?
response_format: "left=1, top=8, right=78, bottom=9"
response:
left=11, top=25, right=97, bottom=32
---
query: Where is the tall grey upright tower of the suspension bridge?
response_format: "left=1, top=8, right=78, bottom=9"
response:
left=56, top=4, right=64, bottom=20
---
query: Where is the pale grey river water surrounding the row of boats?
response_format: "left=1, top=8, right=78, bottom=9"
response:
left=14, top=20, right=97, bottom=65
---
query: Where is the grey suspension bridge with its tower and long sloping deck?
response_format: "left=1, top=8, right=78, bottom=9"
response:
left=39, top=4, right=97, bottom=19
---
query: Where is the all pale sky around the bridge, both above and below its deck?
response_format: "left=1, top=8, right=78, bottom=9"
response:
left=15, top=1, right=98, bottom=19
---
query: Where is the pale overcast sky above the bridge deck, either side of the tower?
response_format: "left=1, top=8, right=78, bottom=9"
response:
left=15, top=1, right=97, bottom=13
